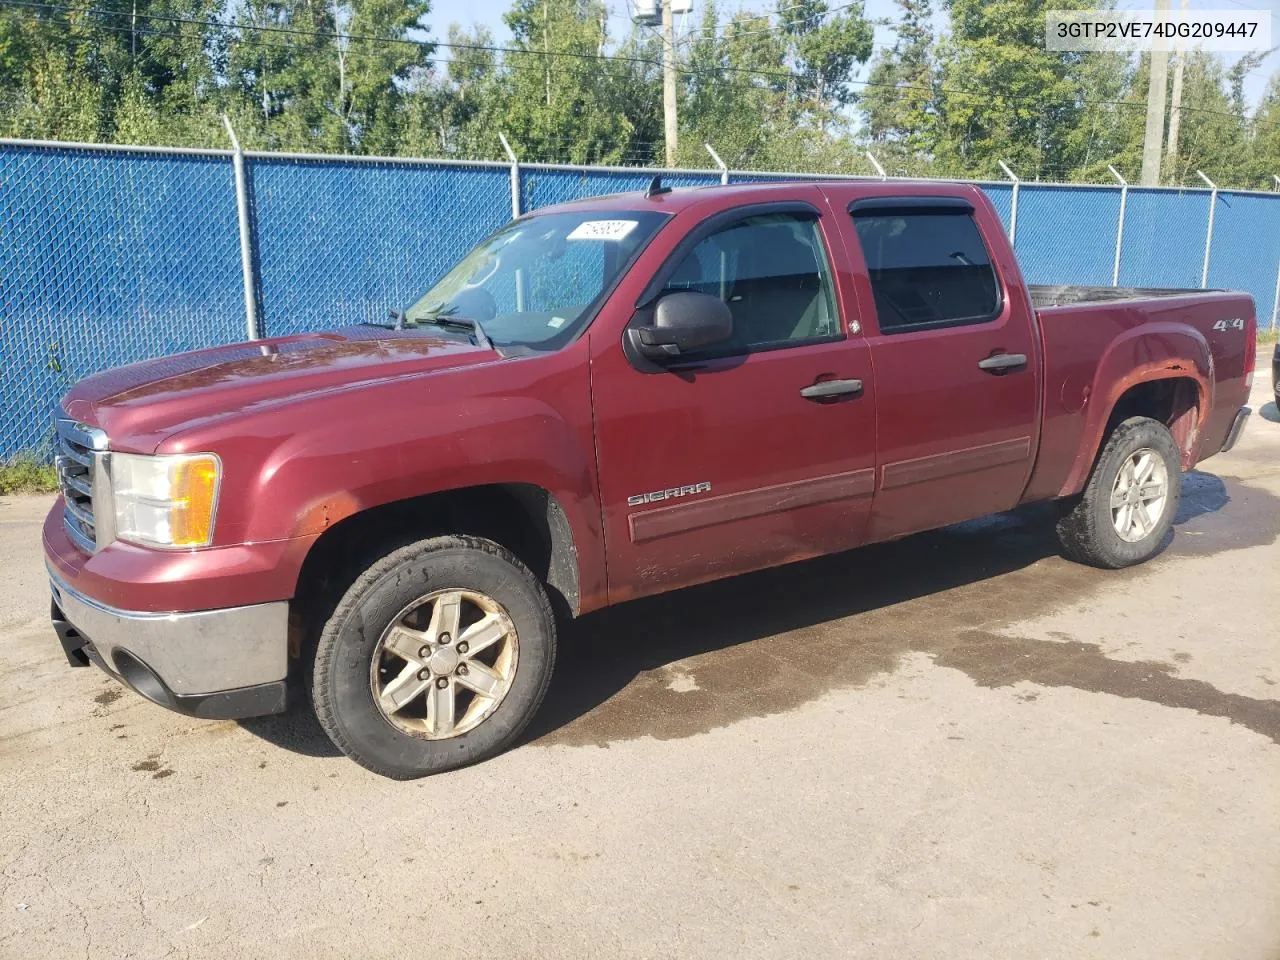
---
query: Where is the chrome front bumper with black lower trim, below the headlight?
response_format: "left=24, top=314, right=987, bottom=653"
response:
left=49, top=571, right=289, bottom=719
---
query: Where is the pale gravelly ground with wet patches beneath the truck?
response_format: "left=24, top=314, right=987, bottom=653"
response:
left=0, top=369, right=1280, bottom=960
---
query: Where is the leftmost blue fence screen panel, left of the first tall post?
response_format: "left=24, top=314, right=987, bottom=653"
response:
left=0, top=147, right=244, bottom=456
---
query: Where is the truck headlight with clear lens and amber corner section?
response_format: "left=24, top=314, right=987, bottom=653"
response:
left=110, top=453, right=221, bottom=547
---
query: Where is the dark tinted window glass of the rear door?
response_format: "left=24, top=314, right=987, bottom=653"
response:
left=854, top=210, right=1000, bottom=334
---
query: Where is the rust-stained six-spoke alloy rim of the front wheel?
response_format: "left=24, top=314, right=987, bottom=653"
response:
left=369, top=590, right=520, bottom=740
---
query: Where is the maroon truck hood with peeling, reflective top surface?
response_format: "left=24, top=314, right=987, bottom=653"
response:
left=63, top=326, right=499, bottom=452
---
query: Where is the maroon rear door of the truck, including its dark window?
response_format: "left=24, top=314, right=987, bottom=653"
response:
left=846, top=196, right=1039, bottom=540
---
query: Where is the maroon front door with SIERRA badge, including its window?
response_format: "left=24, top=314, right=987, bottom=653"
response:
left=591, top=199, right=876, bottom=602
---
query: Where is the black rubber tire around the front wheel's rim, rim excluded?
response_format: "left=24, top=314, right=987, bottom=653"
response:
left=311, top=536, right=556, bottom=780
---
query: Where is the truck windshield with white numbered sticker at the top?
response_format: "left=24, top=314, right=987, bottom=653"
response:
left=404, top=210, right=667, bottom=349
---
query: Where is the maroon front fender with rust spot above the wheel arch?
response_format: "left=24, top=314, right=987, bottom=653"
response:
left=163, top=356, right=604, bottom=609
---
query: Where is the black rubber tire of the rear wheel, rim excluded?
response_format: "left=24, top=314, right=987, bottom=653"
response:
left=1057, top=417, right=1181, bottom=570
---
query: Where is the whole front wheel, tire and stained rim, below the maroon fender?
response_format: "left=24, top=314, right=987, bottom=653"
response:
left=311, top=536, right=556, bottom=780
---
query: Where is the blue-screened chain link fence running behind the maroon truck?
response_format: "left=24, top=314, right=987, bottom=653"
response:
left=0, top=141, right=1280, bottom=458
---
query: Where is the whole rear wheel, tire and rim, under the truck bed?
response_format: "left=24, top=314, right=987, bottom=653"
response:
left=1057, top=417, right=1181, bottom=570
